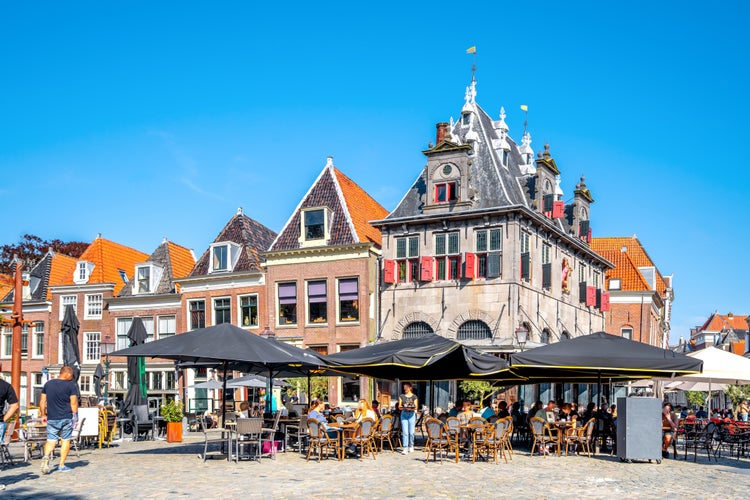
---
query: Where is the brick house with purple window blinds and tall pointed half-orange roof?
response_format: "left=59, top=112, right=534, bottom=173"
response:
left=265, top=158, right=387, bottom=404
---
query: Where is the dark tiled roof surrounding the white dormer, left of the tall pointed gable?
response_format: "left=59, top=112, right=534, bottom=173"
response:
left=189, top=209, right=276, bottom=276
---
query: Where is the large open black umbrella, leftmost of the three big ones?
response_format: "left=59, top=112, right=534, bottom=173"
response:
left=112, top=323, right=325, bottom=412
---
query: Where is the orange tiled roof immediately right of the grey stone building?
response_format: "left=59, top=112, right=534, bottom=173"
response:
left=591, top=235, right=667, bottom=296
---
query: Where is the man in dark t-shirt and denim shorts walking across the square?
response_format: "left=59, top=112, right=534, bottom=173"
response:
left=39, top=366, right=78, bottom=474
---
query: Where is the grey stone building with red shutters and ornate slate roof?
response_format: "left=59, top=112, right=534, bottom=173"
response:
left=374, top=82, right=611, bottom=402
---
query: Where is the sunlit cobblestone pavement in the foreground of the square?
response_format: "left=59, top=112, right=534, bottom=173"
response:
left=0, top=433, right=750, bottom=499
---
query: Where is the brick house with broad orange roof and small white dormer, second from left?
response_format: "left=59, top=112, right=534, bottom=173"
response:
left=45, top=235, right=148, bottom=396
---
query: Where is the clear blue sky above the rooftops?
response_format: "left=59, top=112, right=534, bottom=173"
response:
left=0, top=1, right=750, bottom=341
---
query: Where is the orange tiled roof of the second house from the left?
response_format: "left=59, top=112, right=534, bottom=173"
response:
left=59, top=236, right=148, bottom=295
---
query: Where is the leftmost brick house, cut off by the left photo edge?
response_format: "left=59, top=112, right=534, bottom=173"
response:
left=0, top=250, right=77, bottom=408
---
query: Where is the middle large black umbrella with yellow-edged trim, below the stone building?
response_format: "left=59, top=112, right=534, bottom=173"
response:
left=323, top=334, right=522, bottom=382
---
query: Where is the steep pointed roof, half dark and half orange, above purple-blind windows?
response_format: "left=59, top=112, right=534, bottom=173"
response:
left=270, top=158, right=388, bottom=251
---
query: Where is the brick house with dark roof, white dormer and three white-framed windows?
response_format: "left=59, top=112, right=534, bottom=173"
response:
left=175, top=209, right=276, bottom=411
